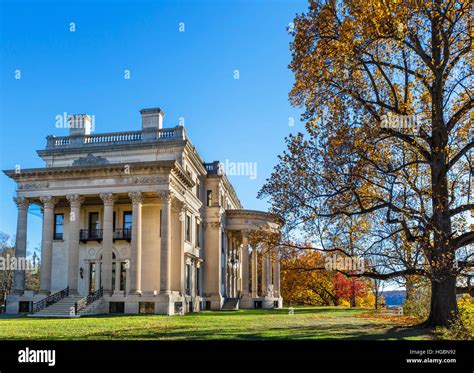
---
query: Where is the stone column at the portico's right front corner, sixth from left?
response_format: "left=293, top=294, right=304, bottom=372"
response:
left=160, top=191, right=172, bottom=294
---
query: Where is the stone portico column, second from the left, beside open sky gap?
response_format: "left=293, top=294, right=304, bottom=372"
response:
left=40, top=196, right=57, bottom=294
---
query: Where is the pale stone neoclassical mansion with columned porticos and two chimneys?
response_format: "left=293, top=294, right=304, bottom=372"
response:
left=4, top=108, right=283, bottom=317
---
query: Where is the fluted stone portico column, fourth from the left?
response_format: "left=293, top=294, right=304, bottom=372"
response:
left=100, top=193, right=117, bottom=294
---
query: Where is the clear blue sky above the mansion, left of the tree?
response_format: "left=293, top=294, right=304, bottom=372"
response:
left=0, top=0, right=307, bottom=252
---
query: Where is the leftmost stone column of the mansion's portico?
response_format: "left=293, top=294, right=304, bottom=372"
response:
left=13, top=197, right=30, bottom=295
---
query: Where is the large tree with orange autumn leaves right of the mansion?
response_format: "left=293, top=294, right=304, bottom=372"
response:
left=260, top=0, right=474, bottom=327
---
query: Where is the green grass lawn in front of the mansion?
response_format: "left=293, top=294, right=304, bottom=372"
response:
left=0, top=307, right=431, bottom=340
